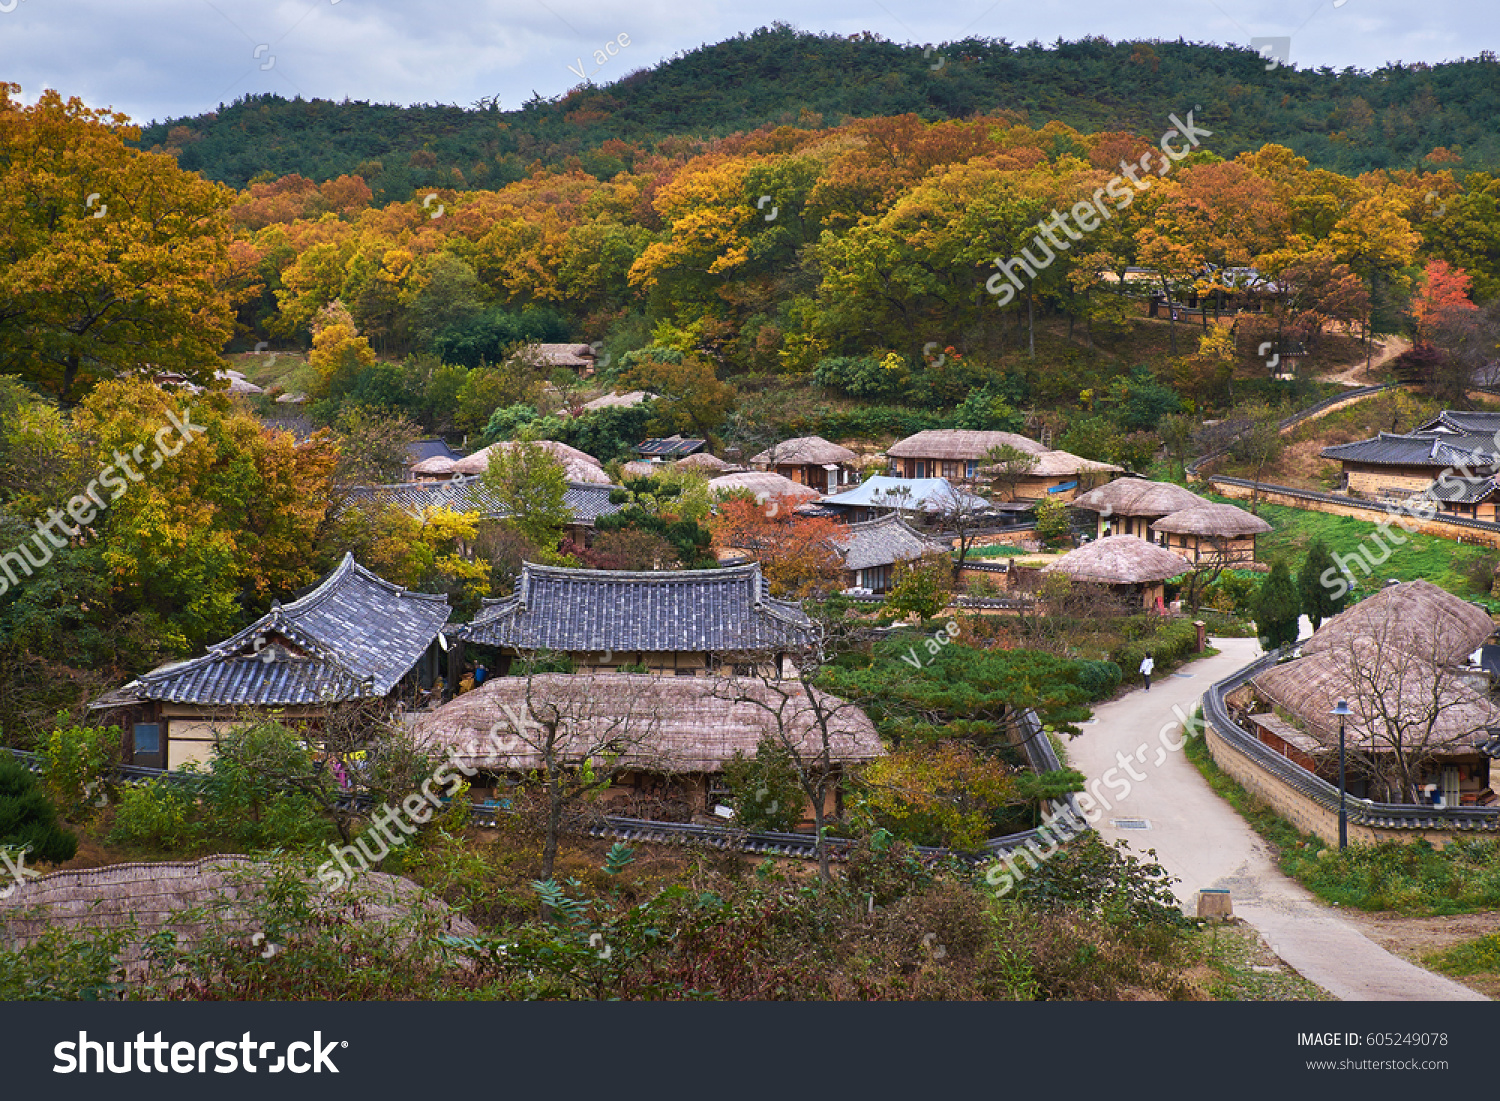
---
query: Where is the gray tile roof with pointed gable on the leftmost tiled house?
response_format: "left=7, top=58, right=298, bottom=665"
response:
left=119, top=555, right=449, bottom=707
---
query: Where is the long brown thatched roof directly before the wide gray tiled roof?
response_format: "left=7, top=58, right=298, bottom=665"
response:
left=413, top=674, right=885, bottom=773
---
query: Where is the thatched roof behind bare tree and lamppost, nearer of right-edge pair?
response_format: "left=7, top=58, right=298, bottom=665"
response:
left=1251, top=641, right=1500, bottom=756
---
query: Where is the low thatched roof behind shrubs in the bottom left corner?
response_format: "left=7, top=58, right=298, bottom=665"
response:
left=0, top=857, right=479, bottom=978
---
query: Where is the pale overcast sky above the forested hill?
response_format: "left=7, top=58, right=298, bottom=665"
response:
left=0, top=0, right=1500, bottom=123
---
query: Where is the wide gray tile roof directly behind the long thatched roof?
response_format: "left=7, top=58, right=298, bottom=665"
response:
left=453, top=563, right=813, bottom=654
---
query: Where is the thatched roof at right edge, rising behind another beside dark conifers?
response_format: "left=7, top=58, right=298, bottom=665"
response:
left=1302, top=581, right=1496, bottom=663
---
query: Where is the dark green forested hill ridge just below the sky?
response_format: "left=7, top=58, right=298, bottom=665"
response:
left=143, top=24, right=1500, bottom=203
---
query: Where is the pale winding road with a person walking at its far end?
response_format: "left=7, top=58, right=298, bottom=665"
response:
left=1067, top=639, right=1488, bottom=1002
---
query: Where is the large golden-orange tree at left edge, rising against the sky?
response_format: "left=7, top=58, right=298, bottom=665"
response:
left=0, top=83, right=245, bottom=405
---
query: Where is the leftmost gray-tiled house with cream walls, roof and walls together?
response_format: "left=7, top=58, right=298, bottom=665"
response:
left=92, top=555, right=450, bottom=768
